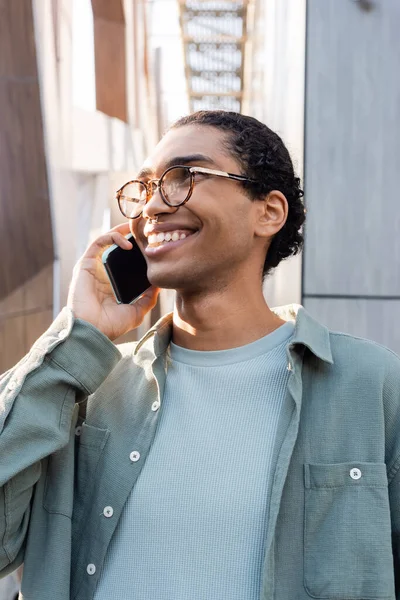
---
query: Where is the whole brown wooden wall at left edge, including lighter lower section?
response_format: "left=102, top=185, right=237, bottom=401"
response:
left=0, top=0, right=54, bottom=372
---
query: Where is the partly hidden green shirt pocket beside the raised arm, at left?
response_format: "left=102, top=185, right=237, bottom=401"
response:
left=72, top=421, right=110, bottom=546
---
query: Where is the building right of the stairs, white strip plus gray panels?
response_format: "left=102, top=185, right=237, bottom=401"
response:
left=243, top=0, right=400, bottom=353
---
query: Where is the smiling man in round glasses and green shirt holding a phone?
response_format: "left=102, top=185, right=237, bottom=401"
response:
left=0, top=111, right=400, bottom=600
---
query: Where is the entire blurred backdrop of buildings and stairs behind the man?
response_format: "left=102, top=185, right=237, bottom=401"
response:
left=0, top=0, right=400, bottom=600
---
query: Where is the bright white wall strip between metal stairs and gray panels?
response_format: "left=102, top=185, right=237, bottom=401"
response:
left=243, top=0, right=304, bottom=314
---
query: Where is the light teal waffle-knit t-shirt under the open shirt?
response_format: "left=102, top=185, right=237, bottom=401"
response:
left=94, top=322, right=294, bottom=600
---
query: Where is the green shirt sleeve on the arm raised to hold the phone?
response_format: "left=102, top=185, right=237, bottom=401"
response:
left=0, top=308, right=121, bottom=574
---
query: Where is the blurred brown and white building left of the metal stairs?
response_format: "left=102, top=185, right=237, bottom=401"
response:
left=0, top=0, right=180, bottom=372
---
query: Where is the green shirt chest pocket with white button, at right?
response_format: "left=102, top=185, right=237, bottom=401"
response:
left=304, top=462, right=394, bottom=600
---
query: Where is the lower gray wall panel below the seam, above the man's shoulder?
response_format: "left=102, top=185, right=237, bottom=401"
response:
left=304, top=298, right=400, bottom=354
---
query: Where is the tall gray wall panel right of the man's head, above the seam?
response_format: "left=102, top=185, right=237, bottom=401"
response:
left=303, top=0, right=400, bottom=296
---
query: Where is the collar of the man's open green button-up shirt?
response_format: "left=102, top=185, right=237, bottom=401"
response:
left=134, top=304, right=333, bottom=364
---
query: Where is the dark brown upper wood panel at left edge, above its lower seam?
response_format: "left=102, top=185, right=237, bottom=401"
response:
left=0, top=0, right=53, bottom=299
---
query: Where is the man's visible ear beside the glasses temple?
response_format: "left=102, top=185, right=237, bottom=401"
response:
left=254, top=190, right=288, bottom=238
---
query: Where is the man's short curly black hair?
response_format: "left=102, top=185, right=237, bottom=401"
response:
left=170, top=110, right=305, bottom=277
